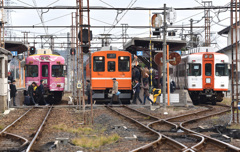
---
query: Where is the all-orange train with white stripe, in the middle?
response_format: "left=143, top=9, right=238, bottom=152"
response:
left=86, top=50, right=132, bottom=101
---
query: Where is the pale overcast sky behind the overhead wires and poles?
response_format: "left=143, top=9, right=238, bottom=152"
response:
left=6, top=0, right=230, bottom=48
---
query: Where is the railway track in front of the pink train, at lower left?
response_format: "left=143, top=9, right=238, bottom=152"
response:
left=0, top=106, right=53, bottom=152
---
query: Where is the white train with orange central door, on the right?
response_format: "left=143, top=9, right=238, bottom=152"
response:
left=173, top=52, right=229, bottom=105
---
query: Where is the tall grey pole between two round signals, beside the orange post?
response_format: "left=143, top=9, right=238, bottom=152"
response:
left=162, top=4, right=167, bottom=109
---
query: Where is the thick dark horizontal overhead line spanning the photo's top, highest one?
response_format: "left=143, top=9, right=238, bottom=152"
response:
left=0, top=6, right=231, bottom=11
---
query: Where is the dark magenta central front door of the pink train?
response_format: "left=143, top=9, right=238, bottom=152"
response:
left=40, top=62, right=50, bottom=87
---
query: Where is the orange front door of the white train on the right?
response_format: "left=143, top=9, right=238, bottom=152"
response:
left=203, top=60, right=214, bottom=89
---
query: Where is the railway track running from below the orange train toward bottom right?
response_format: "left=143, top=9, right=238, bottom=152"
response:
left=107, top=106, right=188, bottom=152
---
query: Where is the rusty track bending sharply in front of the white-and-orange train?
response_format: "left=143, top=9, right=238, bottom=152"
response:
left=148, top=105, right=240, bottom=152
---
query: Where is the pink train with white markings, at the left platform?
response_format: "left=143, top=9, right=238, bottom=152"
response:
left=25, top=54, right=65, bottom=100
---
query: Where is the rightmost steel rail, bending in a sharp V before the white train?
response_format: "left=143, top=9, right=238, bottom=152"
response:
left=180, top=107, right=240, bottom=152
